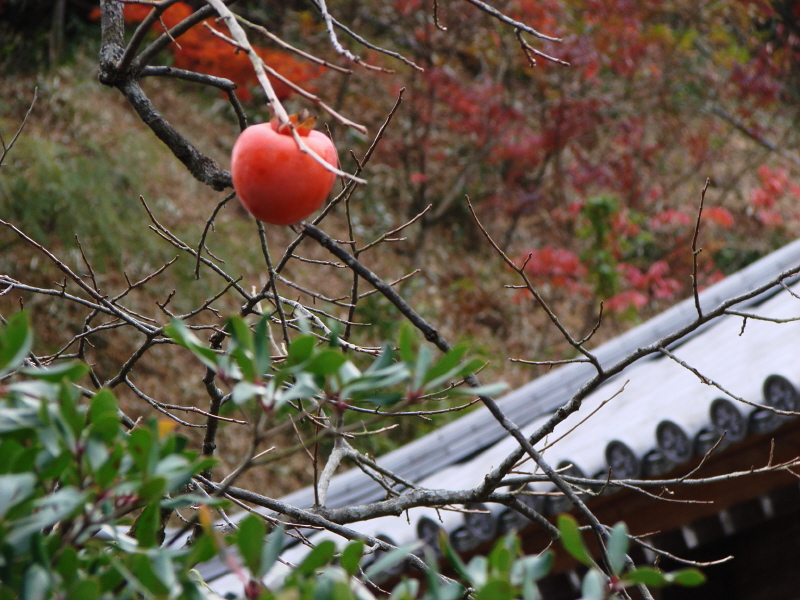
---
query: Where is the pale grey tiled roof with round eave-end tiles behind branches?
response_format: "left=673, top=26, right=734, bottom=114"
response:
left=203, top=237, right=800, bottom=590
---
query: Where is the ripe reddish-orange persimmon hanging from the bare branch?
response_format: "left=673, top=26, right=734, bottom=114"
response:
left=231, top=123, right=339, bottom=225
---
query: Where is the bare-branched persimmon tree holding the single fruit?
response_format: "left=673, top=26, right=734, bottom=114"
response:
left=0, top=0, right=800, bottom=596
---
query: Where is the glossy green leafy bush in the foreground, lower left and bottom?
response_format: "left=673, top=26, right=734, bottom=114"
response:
left=0, top=313, right=703, bottom=600
